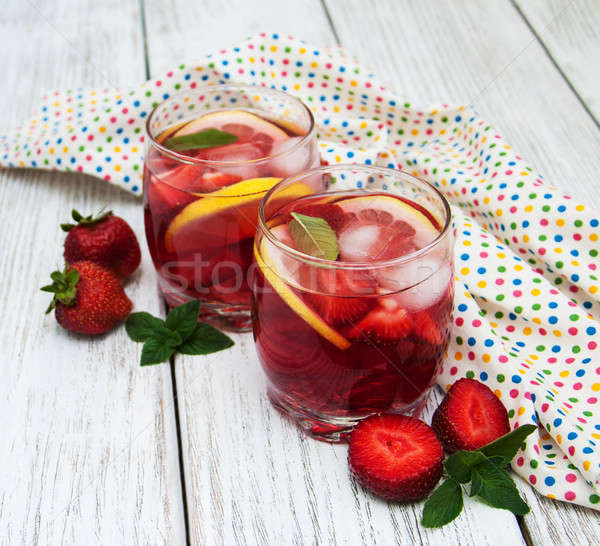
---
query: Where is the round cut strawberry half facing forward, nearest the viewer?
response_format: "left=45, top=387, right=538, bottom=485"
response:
left=348, top=414, right=444, bottom=502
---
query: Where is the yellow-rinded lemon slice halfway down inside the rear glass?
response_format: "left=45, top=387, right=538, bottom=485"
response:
left=165, top=177, right=315, bottom=252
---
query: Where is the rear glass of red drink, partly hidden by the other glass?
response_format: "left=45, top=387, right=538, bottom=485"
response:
left=144, top=85, right=319, bottom=331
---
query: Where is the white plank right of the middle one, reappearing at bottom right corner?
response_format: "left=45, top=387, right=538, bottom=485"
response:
left=326, top=0, right=600, bottom=544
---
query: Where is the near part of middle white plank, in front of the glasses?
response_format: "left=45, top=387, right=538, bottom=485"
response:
left=172, top=335, right=523, bottom=544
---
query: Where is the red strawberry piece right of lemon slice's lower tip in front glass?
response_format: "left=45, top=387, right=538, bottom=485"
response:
left=346, top=297, right=413, bottom=343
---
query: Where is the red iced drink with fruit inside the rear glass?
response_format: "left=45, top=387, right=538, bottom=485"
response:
left=144, top=110, right=317, bottom=307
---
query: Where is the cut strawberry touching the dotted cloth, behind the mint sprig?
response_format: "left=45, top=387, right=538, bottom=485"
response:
left=431, top=378, right=510, bottom=453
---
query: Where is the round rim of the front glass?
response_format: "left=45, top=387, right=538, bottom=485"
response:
left=257, top=163, right=452, bottom=270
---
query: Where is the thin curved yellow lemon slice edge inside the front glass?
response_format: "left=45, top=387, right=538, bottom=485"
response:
left=254, top=228, right=350, bottom=350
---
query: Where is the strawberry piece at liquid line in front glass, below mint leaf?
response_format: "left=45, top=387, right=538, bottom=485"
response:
left=303, top=267, right=376, bottom=324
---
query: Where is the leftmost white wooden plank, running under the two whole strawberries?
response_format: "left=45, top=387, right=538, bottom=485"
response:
left=0, top=0, right=185, bottom=545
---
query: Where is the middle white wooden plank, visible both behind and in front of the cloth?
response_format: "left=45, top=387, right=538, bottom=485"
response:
left=146, top=0, right=522, bottom=544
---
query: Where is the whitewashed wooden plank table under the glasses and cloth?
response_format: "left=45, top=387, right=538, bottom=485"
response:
left=0, top=0, right=600, bottom=546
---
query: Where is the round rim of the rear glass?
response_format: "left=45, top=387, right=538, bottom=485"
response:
left=145, top=83, right=316, bottom=189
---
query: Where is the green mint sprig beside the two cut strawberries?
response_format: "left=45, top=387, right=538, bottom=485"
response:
left=421, top=425, right=537, bottom=527
